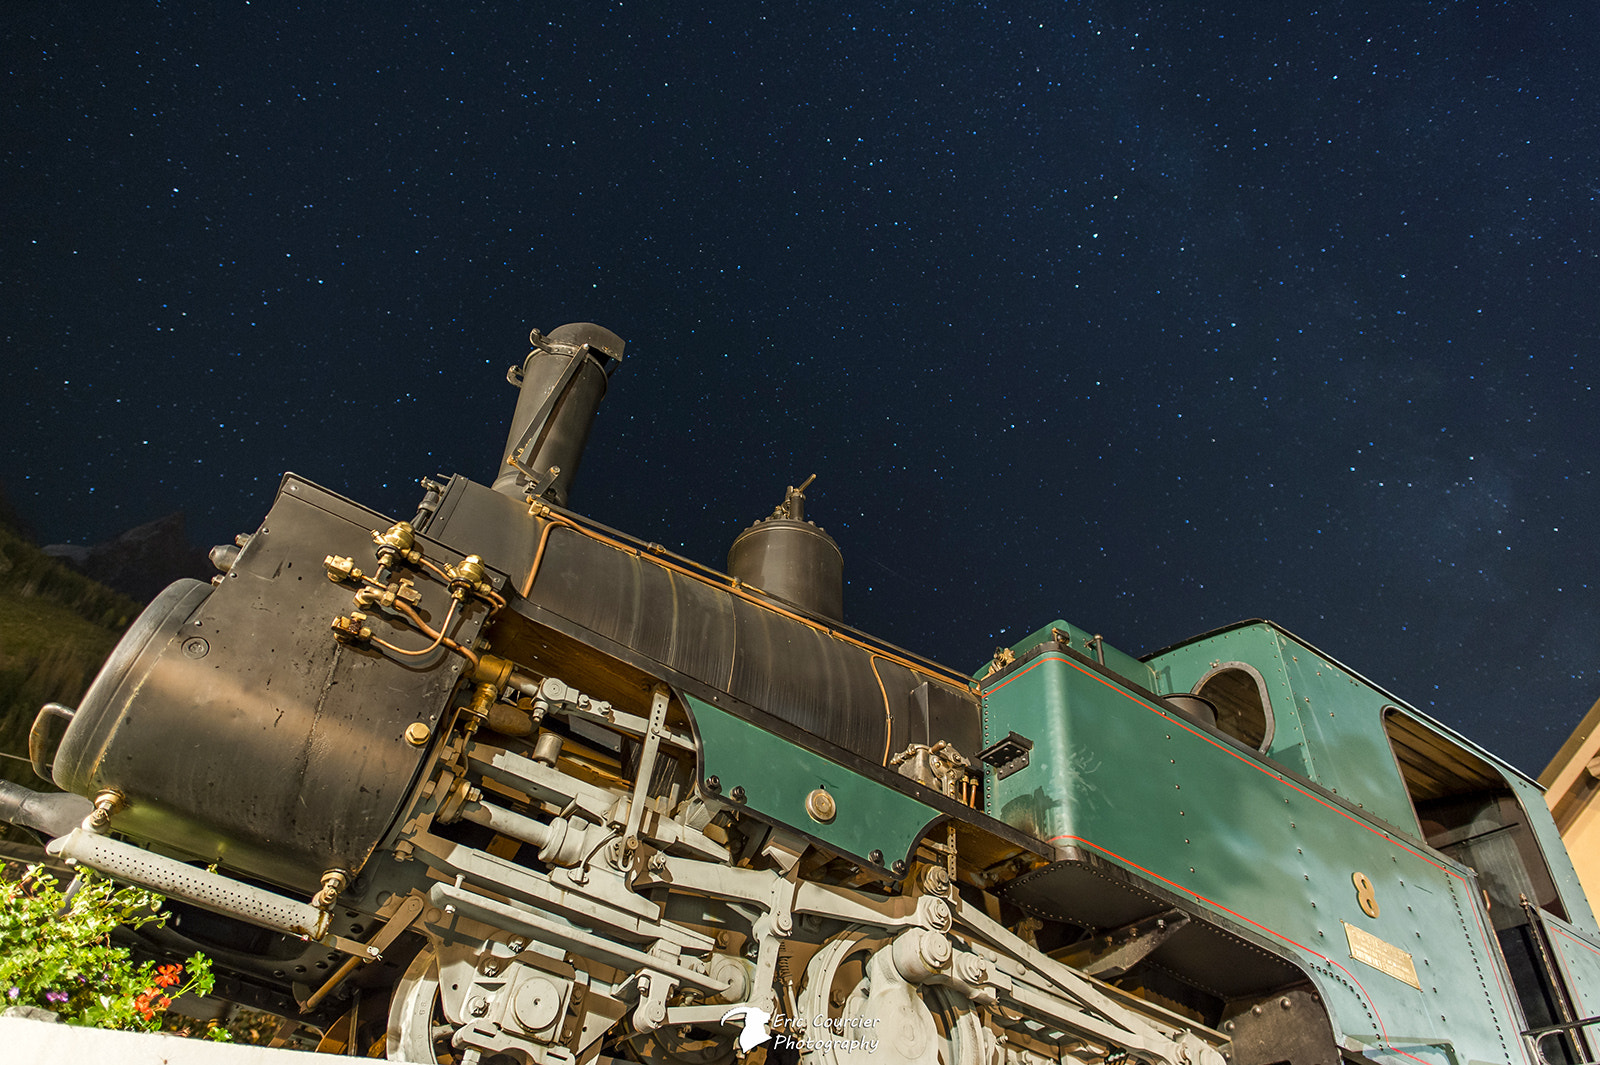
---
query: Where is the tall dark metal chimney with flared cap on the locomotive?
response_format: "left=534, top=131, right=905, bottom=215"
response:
left=494, top=321, right=622, bottom=507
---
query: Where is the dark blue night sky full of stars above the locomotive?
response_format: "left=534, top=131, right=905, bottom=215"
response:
left=0, top=0, right=1600, bottom=774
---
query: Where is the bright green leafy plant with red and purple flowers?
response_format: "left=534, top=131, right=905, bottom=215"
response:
left=0, top=865, right=227, bottom=1039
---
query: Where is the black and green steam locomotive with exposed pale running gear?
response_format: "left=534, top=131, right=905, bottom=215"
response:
left=0, top=323, right=1600, bottom=1065
